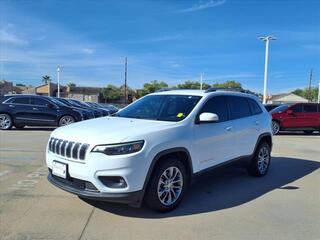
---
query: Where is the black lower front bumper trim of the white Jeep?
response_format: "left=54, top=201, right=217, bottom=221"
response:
left=48, top=170, right=143, bottom=207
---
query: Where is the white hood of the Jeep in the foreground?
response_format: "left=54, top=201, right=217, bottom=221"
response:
left=51, top=117, right=177, bottom=145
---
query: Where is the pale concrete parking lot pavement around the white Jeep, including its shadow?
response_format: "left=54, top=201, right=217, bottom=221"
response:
left=0, top=128, right=320, bottom=240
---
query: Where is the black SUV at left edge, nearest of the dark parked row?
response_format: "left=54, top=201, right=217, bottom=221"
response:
left=0, top=95, right=89, bottom=130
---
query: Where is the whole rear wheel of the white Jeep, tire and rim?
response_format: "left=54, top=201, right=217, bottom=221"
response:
left=247, top=142, right=271, bottom=177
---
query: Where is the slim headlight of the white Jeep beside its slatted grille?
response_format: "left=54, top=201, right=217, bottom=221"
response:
left=92, top=140, right=144, bottom=155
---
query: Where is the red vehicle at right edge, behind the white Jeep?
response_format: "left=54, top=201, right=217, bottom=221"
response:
left=270, top=103, right=320, bottom=135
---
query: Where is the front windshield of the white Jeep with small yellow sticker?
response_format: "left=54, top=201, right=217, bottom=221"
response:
left=115, top=95, right=201, bottom=122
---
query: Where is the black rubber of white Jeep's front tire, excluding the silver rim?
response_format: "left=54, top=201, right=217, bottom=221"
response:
left=144, top=158, right=189, bottom=212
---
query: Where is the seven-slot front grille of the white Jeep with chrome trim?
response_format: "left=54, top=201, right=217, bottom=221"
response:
left=49, top=138, right=89, bottom=160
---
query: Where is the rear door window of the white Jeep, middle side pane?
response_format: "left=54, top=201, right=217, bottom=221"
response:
left=227, top=96, right=251, bottom=119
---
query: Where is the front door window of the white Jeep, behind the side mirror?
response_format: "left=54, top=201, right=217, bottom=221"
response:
left=200, top=96, right=228, bottom=122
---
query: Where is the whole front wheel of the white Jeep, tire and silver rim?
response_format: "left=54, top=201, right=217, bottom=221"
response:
left=144, top=158, right=189, bottom=212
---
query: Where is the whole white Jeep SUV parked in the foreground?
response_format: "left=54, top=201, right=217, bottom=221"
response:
left=46, top=89, right=272, bottom=211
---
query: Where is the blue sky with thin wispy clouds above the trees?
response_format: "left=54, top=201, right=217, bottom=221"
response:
left=0, top=0, right=320, bottom=93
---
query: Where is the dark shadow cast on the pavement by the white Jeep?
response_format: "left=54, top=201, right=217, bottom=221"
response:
left=85, top=157, right=320, bottom=218
